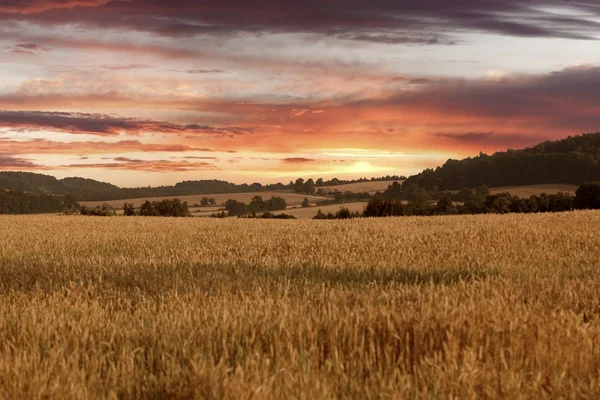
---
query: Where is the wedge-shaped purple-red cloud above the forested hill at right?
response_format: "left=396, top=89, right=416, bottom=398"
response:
left=353, top=67, right=600, bottom=131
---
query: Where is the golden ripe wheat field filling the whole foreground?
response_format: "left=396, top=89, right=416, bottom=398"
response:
left=0, top=212, right=600, bottom=399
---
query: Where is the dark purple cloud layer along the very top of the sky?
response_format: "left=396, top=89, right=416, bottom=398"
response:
left=0, top=0, right=600, bottom=44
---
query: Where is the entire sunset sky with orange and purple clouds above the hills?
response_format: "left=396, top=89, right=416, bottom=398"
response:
left=0, top=0, right=600, bottom=187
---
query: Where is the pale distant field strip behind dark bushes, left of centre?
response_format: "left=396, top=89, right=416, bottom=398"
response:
left=81, top=192, right=323, bottom=208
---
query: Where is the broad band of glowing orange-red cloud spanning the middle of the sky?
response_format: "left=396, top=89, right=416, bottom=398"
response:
left=0, top=67, right=600, bottom=158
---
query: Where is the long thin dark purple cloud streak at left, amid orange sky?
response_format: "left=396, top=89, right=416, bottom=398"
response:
left=0, top=110, right=251, bottom=137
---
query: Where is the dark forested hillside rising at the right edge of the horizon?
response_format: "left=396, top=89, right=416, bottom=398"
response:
left=404, top=133, right=600, bottom=190
